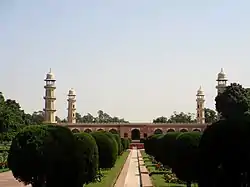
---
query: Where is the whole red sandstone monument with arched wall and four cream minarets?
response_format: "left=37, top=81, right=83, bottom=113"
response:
left=44, top=69, right=227, bottom=139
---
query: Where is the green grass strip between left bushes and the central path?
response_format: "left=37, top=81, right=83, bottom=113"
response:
left=84, top=151, right=129, bottom=187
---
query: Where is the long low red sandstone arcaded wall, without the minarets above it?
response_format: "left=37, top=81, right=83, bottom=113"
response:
left=63, top=123, right=209, bottom=138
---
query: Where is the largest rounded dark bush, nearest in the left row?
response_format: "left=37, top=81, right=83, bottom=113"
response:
left=8, top=125, right=80, bottom=187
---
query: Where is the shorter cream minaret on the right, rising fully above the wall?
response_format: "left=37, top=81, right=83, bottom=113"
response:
left=196, top=87, right=205, bottom=124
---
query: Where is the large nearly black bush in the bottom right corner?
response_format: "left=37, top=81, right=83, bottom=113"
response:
left=198, top=118, right=250, bottom=187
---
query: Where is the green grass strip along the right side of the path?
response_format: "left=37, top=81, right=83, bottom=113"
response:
left=141, top=151, right=197, bottom=187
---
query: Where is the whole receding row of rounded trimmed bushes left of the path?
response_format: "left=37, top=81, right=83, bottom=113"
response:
left=7, top=128, right=129, bottom=187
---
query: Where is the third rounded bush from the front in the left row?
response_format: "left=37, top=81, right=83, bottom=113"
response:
left=91, top=131, right=117, bottom=169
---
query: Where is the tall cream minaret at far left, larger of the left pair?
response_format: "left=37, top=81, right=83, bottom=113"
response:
left=43, top=69, right=56, bottom=124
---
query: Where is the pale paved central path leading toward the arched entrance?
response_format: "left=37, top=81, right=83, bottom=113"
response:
left=114, top=149, right=140, bottom=187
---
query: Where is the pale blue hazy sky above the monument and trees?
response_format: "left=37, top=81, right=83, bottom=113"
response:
left=0, top=0, right=250, bottom=122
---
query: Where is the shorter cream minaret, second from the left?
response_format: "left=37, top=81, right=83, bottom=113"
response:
left=68, top=88, right=76, bottom=123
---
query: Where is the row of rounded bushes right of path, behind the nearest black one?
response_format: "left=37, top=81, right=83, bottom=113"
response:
left=144, top=132, right=201, bottom=185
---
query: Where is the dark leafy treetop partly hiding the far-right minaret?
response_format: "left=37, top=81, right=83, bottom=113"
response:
left=215, top=83, right=250, bottom=119
